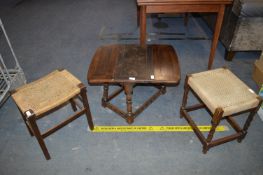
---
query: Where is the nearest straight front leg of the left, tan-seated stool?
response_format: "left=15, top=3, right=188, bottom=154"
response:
left=27, top=114, right=50, bottom=160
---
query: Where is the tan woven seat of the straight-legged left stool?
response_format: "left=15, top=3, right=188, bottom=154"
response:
left=12, top=70, right=81, bottom=116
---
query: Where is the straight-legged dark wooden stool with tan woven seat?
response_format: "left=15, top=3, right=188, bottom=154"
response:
left=12, top=70, right=94, bottom=160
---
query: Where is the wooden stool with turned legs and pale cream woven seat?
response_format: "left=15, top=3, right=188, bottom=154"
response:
left=181, top=68, right=262, bottom=153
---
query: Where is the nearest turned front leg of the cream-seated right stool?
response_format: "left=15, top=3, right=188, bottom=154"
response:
left=203, top=108, right=224, bottom=154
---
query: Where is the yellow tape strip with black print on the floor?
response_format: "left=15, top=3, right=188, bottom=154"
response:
left=92, top=125, right=229, bottom=132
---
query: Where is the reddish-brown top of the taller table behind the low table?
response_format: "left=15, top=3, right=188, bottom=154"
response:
left=137, top=0, right=233, bottom=5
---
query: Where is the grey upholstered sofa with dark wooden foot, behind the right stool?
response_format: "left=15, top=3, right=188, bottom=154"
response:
left=204, top=0, right=263, bottom=61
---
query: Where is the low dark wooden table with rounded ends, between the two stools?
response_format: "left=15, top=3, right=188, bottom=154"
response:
left=88, top=45, right=180, bottom=124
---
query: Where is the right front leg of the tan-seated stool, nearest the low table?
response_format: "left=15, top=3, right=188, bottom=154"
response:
left=80, top=84, right=94, bottom=130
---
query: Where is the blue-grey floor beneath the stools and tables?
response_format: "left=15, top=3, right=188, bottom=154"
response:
left=0, top=0, right=263, bottom=175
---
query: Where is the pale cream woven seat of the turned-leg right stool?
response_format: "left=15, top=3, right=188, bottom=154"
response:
left=188, top=68, right=259, bottom=116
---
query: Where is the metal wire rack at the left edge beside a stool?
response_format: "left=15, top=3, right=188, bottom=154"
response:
left=0, top=19, right=26, bottom=107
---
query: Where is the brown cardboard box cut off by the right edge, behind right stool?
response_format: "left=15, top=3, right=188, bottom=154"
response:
left=252, top=57, right=263, bottom=87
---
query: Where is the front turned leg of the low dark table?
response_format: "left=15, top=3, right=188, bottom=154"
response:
left=124, top=84, right=134, bottom=124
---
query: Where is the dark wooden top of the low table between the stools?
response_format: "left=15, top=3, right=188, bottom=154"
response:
left=88, top=44, right=180, bottom=84
